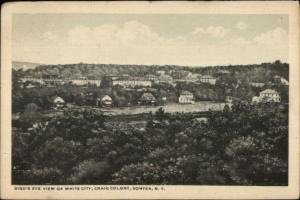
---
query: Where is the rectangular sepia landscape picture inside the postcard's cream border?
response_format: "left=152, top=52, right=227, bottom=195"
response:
left=1, top=0, right=299, bottom=199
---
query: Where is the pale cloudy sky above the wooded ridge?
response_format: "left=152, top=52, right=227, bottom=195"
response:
left=12, top=14, right=289, bottom=66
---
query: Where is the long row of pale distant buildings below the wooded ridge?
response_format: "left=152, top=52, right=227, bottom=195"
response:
left=20, top=70, right=236, bottom=88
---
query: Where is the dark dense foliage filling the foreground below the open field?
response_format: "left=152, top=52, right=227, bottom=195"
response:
left=12, top=102, right=288, bottom=185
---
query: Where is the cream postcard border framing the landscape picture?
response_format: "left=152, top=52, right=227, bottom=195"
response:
left=1, top=1, right=299, bottom=199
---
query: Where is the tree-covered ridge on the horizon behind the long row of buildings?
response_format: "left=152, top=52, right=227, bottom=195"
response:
left=20, top=61, right=289, bottom=82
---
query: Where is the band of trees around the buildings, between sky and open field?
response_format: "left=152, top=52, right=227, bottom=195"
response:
left=12, top=61, right=289, bottom=113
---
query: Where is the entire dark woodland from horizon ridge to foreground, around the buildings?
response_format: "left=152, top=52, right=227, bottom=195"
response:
left=12, top=61, right=289, bottom=186
